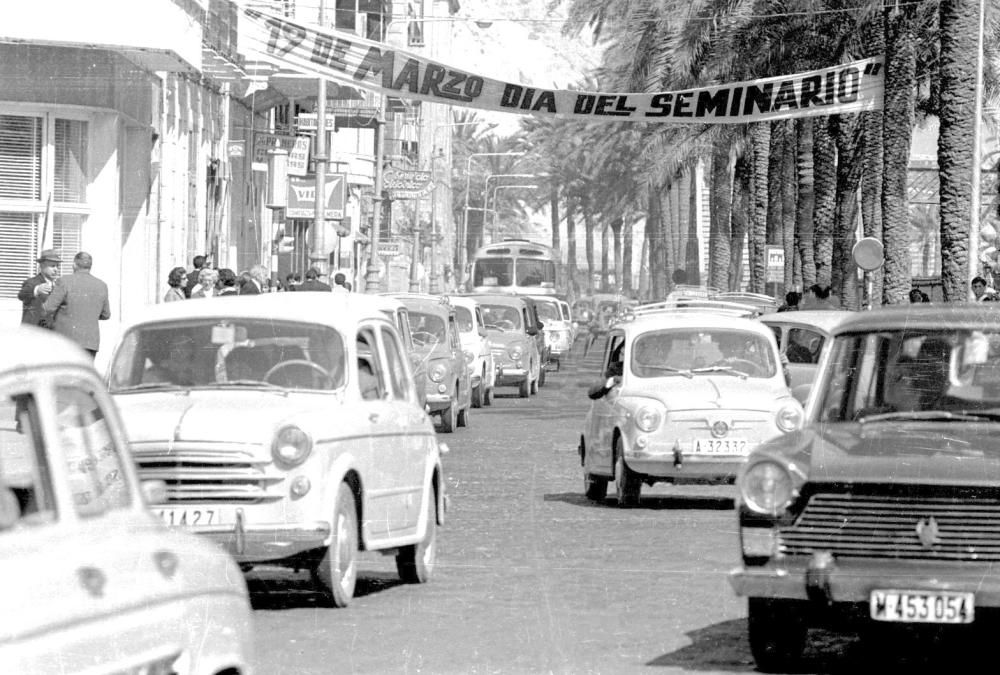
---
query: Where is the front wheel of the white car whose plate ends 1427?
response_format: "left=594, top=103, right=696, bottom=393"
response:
left=314, top=483, right=358, bottom=607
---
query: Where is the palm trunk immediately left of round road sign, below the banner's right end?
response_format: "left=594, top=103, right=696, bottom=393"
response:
left=830, top=115, right=861, bottom=309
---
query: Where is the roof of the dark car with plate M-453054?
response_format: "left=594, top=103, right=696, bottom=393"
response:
left=833, top=302, right=1000, bottom=335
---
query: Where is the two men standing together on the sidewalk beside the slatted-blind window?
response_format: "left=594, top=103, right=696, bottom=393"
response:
left=17, top=248, right=111, bottom=357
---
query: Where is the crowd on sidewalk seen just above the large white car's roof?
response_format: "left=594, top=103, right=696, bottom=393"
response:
left=163, top=255, right=351, bottom=302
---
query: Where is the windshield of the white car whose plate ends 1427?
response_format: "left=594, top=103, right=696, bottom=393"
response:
left=109, top=318, right=345, bottom=392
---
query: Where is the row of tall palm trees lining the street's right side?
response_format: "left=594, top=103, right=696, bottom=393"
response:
left=456, top=0, right=1000, bottom=303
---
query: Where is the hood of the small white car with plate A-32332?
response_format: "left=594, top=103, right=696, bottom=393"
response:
left=621, top=375, right=793, bottom=412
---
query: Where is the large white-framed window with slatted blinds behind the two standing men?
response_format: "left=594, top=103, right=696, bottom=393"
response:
left=0, top=113, right=90, bottom=298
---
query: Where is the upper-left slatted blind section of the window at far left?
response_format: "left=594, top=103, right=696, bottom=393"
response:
left=0, top=115, right=42, bottom=199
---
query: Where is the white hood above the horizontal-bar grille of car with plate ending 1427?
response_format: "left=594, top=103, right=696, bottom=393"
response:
left=114, top=389, right=337, bottom=445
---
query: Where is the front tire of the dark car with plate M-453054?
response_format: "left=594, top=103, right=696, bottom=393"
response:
left=747, top=598, right=806, bottom=673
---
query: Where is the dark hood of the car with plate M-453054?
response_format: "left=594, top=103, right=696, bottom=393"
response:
left=761, top=422, right=1000, bottom=485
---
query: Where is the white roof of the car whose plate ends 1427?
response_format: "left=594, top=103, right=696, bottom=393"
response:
left=120, top=292, right=385, bottom=331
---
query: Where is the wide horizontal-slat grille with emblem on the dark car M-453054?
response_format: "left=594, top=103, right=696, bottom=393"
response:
left=779, top=493, right=1000, bottom=561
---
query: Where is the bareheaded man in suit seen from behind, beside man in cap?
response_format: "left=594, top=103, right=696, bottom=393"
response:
left=42, top=251, right=111, bottom=356
